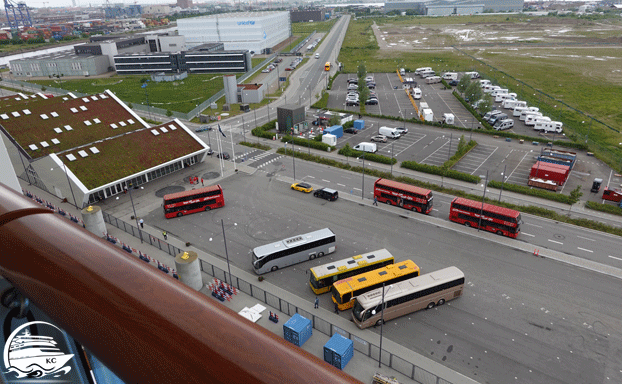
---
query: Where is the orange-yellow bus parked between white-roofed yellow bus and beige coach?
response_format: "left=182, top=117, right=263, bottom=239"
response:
left=331, top=260, right=419, bottom=311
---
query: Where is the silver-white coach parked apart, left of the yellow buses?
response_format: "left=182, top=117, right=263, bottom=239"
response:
left=252, top=228, right=336, bottom=275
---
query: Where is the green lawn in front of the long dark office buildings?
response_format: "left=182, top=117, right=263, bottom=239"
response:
left=31, top=74, right=239, bottom=113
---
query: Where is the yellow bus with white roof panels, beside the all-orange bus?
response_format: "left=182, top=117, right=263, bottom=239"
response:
left=309, top=249, right=395, bottom=295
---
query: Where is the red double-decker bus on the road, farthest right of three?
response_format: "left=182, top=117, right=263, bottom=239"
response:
left=449, top=197, right=522, bottom=238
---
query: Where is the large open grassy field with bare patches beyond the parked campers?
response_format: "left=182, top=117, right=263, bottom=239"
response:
left=339, top=15, right=622, bottom=171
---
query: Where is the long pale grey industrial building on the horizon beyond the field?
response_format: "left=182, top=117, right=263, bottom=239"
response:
left=384, top=0, right=525, bottom=16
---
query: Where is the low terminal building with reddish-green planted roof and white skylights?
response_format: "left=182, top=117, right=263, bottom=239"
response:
left=0, top=91, right=209, bottom=208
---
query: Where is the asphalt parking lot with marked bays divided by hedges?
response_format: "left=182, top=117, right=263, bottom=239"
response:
left=320, top=73, right=622, bottom=202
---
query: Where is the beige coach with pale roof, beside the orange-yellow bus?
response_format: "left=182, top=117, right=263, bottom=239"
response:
left=352, top=267, right=464, bottom=329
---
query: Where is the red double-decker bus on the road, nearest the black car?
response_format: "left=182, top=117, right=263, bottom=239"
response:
left=374, top=179, right=433, bottom=214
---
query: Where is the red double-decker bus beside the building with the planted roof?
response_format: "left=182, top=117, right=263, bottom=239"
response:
left=163, top=185, right=225, bottom=219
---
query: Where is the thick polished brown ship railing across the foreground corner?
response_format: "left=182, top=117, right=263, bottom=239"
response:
left=0, top=183, right=359, bottom=383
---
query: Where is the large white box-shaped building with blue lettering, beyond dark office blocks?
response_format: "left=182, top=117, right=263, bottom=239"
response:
left=177, top=12, right=291, bottom=53
